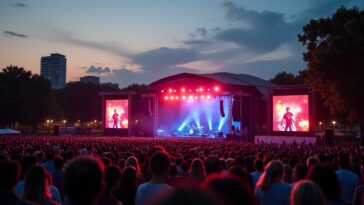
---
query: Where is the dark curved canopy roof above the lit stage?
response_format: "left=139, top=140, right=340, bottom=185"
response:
left=149, top=72, right=275, bottom=96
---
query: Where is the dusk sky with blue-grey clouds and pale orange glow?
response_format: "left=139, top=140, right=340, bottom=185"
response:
left=0, top=0, right=364, bottom=87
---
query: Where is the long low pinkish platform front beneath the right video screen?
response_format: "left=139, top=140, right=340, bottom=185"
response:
left=254, top=135, right=316, bottom=144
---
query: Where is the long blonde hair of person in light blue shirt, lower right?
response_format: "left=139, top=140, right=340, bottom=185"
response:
left=257, top=160, right=283, bottom=191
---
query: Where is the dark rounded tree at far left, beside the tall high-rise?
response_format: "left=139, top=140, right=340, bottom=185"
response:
left=0, top=66, right=52, bottom=131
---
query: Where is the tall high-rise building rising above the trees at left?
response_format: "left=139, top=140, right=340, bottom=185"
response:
left=40, top=53, right=66, bottom=89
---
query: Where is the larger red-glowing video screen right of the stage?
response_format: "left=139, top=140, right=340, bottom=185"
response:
left=272, top=95, right=309, bottom=132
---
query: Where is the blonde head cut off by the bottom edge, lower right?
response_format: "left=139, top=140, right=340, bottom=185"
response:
left=290, top=180, right=327, bottom=205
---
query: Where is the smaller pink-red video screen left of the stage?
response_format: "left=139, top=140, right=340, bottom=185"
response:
left=105, top=100, right=128, bottom=129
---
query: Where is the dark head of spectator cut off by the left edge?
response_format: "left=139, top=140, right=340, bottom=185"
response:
left=0, top=160, right=21, bottom=192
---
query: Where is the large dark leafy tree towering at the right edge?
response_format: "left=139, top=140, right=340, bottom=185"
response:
left=298, top=7, right=364, bottom=146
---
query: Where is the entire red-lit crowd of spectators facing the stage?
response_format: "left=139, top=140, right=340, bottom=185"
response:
left=0, top=136, right=364, bottom=205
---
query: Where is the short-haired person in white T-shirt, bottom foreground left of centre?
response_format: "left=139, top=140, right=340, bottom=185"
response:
left=135, top=151, right=173, bottom=205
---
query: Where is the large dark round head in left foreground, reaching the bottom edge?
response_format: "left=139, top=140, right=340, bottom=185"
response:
left=64, top=157, right=105, bottom=205
